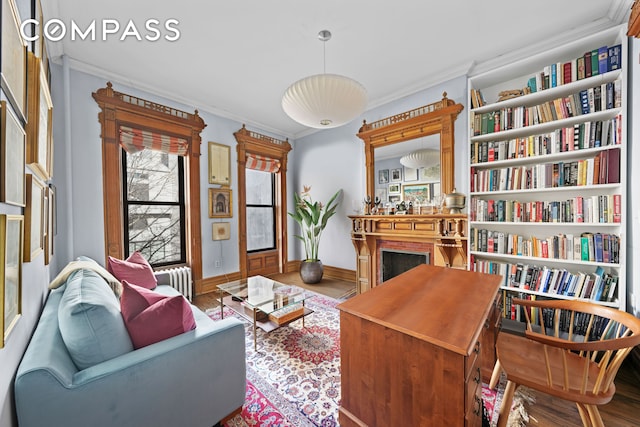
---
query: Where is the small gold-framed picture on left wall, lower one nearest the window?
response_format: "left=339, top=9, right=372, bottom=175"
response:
left=24, top=173, right=45, bottom=262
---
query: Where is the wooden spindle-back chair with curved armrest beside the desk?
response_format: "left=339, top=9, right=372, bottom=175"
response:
left=490, top=299, right=640, bottom=427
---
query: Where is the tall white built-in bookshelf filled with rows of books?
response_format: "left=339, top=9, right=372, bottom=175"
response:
left=468, top=27, right=627, bottom=320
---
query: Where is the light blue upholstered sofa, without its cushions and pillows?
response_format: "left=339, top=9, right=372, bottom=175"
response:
left=15, top=264, right=246, bottom=427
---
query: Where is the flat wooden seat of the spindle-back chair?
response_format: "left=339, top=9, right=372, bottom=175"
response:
left=496, top=332, right=616, bottom=405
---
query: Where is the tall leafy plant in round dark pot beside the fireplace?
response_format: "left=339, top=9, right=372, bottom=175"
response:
left=289, top=185, right=342, bottom=284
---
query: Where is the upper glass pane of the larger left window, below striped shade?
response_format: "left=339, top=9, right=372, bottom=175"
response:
left=127, top=150, right=180, bottom=202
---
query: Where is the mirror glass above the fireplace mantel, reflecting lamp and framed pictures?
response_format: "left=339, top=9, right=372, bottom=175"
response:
left=374, top=134, right=441, bottom=213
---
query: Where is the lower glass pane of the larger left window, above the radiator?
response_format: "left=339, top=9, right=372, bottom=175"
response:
left=129, top=205, right=182, bottom=264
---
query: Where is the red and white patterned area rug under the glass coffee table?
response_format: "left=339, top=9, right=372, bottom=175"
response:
left=207, top=294, right=526, bottom=427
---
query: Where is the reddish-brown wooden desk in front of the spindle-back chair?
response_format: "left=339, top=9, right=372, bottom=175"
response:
left=338, top=265, right=501, bottom=427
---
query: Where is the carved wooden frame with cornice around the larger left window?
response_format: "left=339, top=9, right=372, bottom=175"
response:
left=92, top=82, right=206, bottom=290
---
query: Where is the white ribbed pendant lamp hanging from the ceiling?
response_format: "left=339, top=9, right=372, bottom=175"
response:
left=282, top=30, right=367, bottom=129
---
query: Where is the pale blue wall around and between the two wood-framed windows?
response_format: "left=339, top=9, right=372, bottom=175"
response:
left=48, top=65, right=292, bottom=278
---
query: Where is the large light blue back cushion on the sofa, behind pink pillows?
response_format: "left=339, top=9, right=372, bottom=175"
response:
left=58, top=269, right=133, bottom=370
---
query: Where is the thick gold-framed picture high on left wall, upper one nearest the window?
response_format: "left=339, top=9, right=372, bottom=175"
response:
left=27, top=52, right=53, bottom=181
